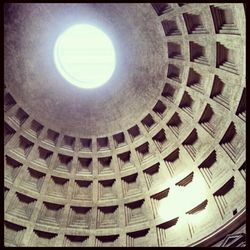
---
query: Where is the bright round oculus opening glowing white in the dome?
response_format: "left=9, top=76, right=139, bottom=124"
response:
left=54, top=24, right=116, bottom=89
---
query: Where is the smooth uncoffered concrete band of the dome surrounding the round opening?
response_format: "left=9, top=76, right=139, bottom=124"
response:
left=5, top=4, right=168, bottom=136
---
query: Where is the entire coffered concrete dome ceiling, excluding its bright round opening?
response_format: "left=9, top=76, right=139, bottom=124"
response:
left=4, top=3, right=246, bottom=247
